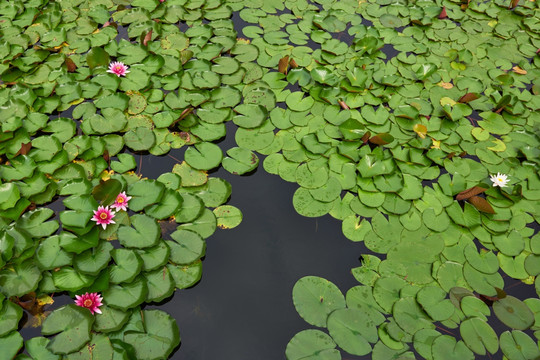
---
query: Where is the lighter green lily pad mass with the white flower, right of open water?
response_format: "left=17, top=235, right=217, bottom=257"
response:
left=230, top=1, right=540, bottom=360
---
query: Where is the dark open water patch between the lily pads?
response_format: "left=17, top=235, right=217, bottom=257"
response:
left=142, top=123, right=369, bottom=360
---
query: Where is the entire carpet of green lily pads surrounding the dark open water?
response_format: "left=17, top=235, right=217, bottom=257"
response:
left=0, top=0, right=540, bottom=360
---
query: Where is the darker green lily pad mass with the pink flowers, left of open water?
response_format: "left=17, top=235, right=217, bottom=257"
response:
left=0, top=0, right=242, bottom=359
